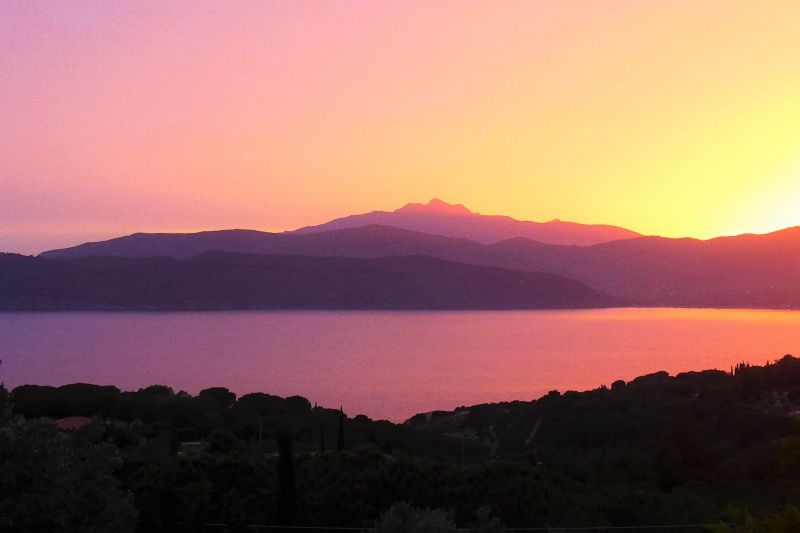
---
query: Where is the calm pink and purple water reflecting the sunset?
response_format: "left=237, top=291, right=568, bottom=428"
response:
left=0, top=309, right=800, bottom=421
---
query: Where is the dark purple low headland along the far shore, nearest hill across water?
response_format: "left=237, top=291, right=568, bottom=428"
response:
left=0, top=252, right=619, bottom=310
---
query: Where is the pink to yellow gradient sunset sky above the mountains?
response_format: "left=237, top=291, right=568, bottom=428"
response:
left=0, top=0, right=800, bottom=253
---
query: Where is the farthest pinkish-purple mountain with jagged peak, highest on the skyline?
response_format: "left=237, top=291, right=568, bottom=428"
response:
left=295, top=199, right=640, bottom=246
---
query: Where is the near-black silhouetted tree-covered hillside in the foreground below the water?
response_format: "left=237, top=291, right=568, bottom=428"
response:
left=0, top=356, right=800, bottom=532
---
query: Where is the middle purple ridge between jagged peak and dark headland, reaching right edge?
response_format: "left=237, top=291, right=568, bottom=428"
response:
left=42, top=226, right=800, bottom=309
